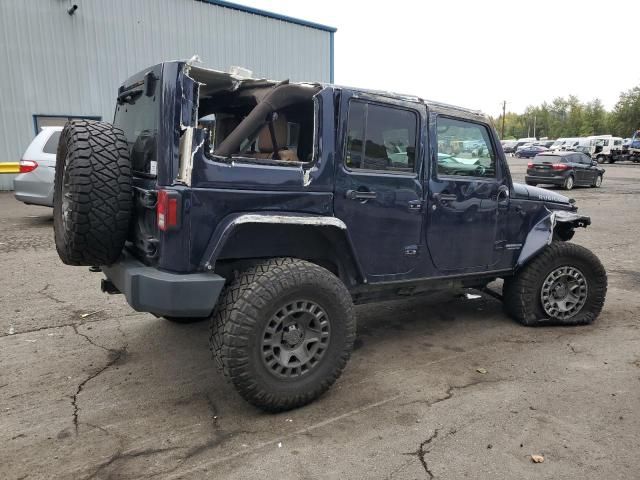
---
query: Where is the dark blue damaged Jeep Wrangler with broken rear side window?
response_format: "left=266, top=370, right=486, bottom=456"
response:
left=54, top=62, right=607, bottom=411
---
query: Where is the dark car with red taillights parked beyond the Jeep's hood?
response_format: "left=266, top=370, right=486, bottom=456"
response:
left=524, top=152, right=604, bottom=190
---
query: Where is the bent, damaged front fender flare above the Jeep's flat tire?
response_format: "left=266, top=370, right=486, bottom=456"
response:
left=516, top=208, right=591, bottom=268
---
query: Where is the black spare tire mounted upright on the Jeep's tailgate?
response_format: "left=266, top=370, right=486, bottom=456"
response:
left=53, top=120, right=133, bottom=265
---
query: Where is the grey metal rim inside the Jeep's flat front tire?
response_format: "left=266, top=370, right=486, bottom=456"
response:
left=540, top=266, right=589, bottom=320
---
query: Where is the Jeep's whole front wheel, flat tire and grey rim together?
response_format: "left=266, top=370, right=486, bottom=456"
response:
left=503, top=242, right=607, bottom=326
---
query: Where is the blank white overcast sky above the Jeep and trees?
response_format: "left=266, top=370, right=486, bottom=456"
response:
left=235, top=0, right=640, bottom=116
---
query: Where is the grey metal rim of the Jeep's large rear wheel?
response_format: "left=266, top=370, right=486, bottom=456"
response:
left=261, top=300, right=331, bottom=378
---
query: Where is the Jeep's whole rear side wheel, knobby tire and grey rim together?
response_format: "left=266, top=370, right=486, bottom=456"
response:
left=210, top=258, right=356, bottom=412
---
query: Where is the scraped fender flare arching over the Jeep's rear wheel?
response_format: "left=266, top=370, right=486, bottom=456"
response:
left=200, top=212, right=366, bottom=278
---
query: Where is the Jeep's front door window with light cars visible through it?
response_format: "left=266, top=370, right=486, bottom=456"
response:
left=437, top=117, right=496, bottom=178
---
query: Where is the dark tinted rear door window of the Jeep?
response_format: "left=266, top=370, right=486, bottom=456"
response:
left=345, top=101, right=418, bottom=172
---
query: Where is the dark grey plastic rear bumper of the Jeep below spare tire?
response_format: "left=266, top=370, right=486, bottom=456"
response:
left=102, top=252, right=225, bottom=317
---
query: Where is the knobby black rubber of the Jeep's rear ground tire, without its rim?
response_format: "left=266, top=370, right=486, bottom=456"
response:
left=210, top=258, right=356, bottom=412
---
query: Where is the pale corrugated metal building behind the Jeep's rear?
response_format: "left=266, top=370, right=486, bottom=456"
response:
left=0, top=0, right=336, bottom=190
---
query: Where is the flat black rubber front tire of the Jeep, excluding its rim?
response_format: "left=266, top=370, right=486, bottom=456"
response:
left=502, top=241, right=607, bottom=326
